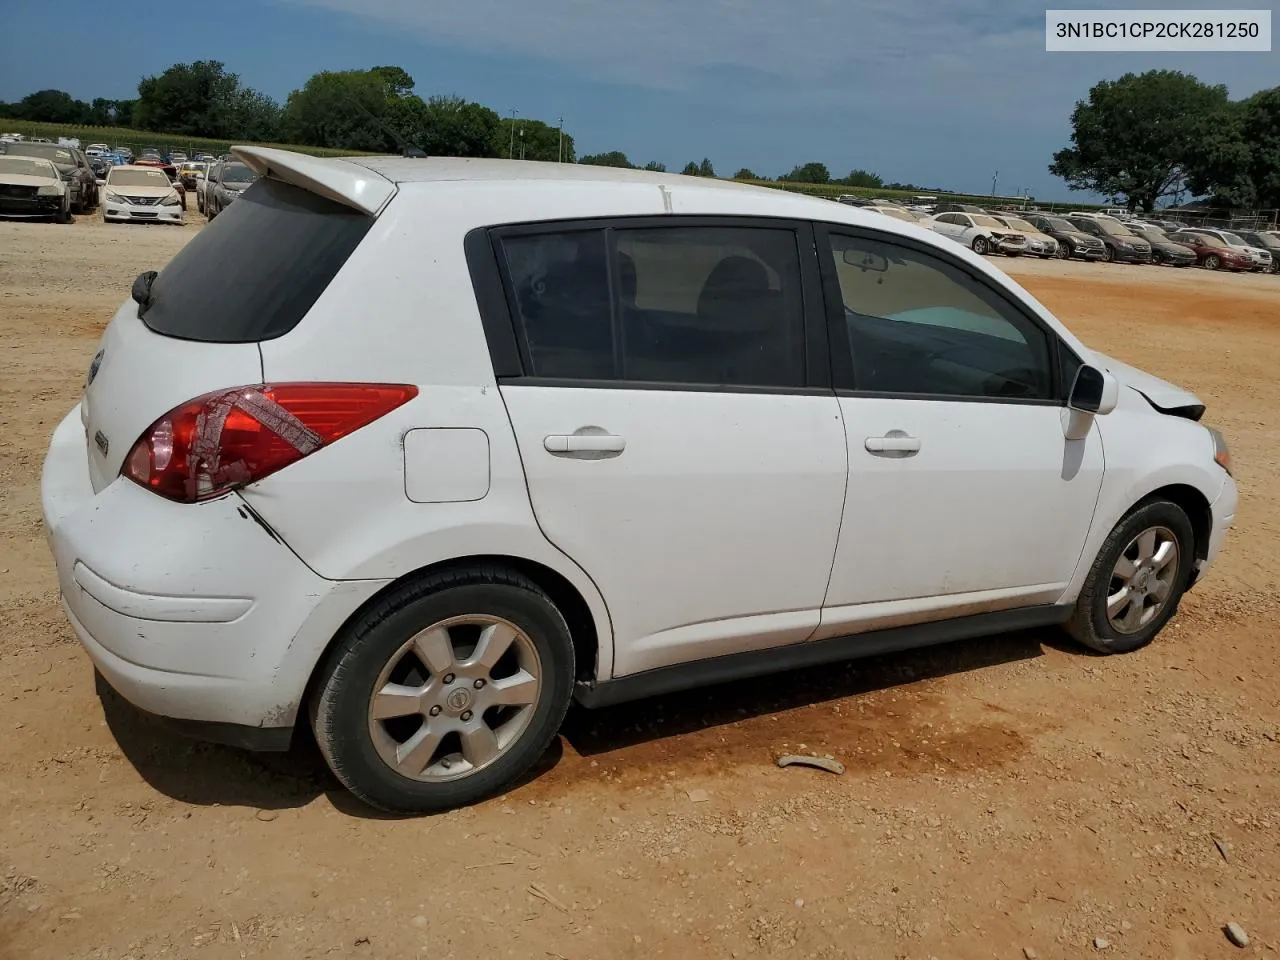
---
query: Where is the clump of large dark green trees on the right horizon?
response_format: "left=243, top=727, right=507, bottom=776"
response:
left=1048, top=70, right=1280, bottom=212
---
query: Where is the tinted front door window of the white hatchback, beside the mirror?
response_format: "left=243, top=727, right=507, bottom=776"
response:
left=832, top=236, right=1052, bottom=399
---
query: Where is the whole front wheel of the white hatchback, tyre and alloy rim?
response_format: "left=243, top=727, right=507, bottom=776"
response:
left=1066, top=500, right=1196, bottom=653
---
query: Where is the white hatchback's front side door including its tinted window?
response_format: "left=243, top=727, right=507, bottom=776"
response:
left=815, top=227, right=1103, bottom=637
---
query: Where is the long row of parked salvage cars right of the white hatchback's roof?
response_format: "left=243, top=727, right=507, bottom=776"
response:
left=840, top=197, right=1280, bottom=273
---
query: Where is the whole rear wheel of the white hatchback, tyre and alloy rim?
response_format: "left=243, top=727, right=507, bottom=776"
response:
left=312, top=567, right=573, bottom=813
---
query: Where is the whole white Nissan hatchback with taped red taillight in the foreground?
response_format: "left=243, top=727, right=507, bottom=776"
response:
left=42, top=148, right=1236, bottom=810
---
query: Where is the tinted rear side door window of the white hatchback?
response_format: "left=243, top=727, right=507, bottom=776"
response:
left=502, top=227, right=805, bottom=387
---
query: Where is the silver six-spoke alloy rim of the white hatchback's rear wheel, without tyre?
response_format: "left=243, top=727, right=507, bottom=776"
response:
left=369, top=613, right=543, bottom=782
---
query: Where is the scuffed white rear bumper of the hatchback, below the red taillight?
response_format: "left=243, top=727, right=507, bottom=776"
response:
left=41, top=407, right=385, bottom=745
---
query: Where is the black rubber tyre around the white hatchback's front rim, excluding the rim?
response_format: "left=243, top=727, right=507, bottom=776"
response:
left=1066, top=499, right=1196, bottom=653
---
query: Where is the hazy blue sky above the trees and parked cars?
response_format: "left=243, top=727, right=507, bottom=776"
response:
left=0, top=0, right=1280, bottom=200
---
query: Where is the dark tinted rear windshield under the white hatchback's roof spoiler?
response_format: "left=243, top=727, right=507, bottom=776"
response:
left=142, top=179, right=374, bottom=343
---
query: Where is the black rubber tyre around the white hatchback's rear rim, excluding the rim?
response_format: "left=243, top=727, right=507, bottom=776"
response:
left=311, top=566, right=573, bottom=813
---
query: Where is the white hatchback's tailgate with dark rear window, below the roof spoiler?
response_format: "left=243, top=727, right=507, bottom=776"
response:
left=81, top=179, right=372, bottom=490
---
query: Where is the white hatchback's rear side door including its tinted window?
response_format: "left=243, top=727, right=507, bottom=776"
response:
left=493, top=216, right=847, bottom=677
